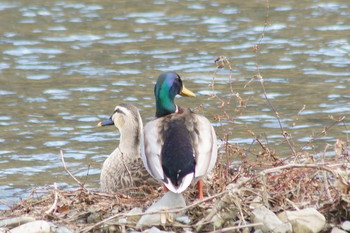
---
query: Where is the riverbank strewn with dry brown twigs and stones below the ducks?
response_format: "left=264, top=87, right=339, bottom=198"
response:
left=0, top=147, right=350, bottom=232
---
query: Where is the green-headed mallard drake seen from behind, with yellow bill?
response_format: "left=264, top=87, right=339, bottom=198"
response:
left=141, top=72, right=217, bottom=199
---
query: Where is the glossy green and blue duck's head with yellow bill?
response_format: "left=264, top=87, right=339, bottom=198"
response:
left=154, top=71, right=196, bottom=117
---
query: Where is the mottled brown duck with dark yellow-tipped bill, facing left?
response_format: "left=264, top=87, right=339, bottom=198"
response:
left=98, top=103, right=157, bottom=193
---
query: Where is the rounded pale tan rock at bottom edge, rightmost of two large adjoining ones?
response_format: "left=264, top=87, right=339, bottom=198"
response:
left=278, top=208, right=326, bottom=233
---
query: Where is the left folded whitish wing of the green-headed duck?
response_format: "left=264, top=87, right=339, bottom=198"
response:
left=141, top=118, right=164, bottom=181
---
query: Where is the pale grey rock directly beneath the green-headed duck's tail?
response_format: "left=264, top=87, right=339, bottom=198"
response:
left=137, top=191, right=186, bottom=228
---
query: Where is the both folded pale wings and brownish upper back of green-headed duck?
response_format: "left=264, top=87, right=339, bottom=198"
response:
left=141, top=110, right=217, bottom=189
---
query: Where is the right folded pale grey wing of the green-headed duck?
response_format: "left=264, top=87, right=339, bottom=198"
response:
left=192, top=114, right=217, bottom=178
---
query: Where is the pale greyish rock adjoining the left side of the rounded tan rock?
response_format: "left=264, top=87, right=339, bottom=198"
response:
left=252, top=206, right=292, bottom=233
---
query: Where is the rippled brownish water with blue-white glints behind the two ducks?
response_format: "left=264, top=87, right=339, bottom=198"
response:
left=0, top=0, right=350, bottom=209
